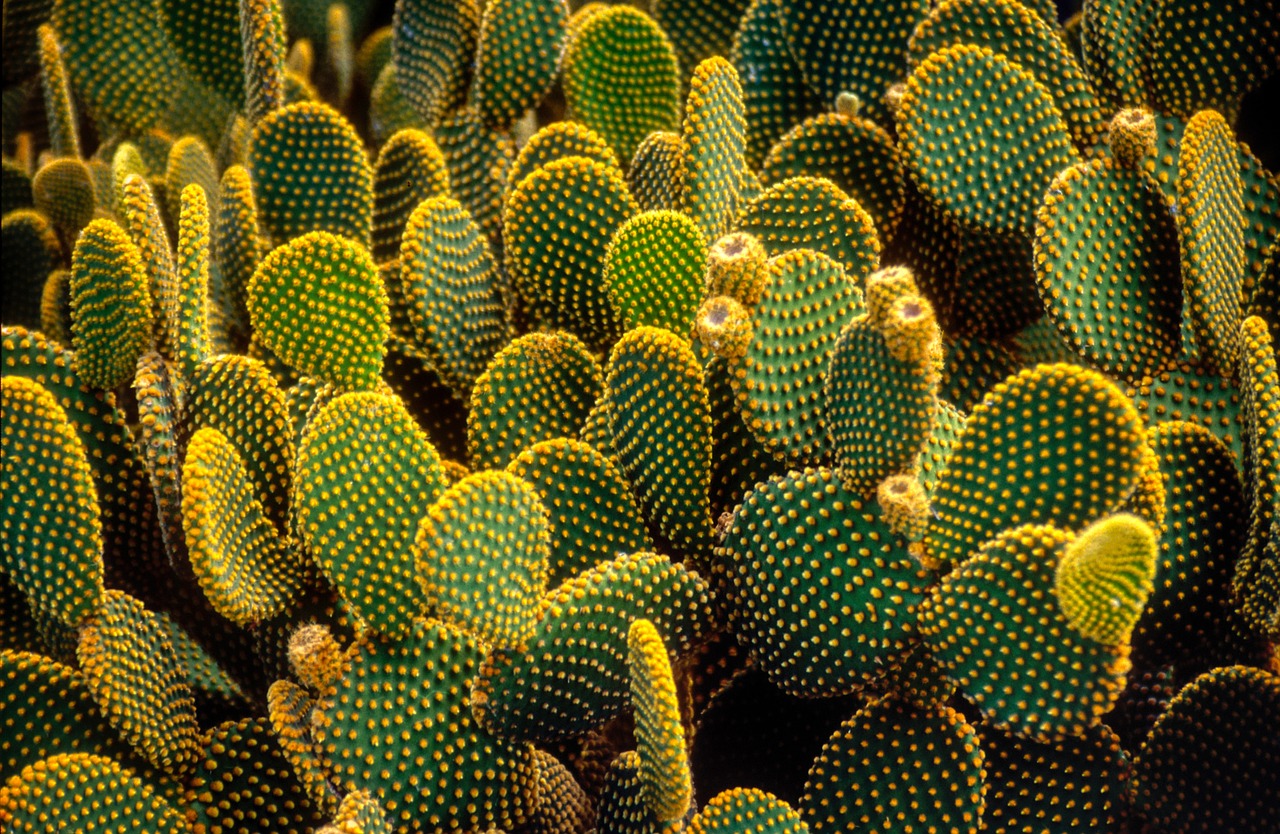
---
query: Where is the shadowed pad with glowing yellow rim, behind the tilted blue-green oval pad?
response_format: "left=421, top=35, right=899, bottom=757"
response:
left=372, top=128, right=449, bottom=264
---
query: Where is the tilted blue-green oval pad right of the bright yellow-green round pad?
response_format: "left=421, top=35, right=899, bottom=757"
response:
left=390, top=197, right=507, bottom=399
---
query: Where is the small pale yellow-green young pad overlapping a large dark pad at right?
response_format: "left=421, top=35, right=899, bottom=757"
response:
left=1053, top=515, right=1156, bottom=646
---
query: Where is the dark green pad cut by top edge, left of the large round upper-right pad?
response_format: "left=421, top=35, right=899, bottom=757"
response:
left=778, top=0, right=929, bottom=119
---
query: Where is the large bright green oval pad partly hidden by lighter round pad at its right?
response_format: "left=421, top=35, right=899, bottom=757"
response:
left=294, top=394, right=444, bottom=636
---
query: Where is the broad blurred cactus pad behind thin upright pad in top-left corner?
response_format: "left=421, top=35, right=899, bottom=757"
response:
left=54, top=0, right=180, bottom=133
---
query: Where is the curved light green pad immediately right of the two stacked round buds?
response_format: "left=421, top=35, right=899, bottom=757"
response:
left=739, top=249, right=863, bottom=460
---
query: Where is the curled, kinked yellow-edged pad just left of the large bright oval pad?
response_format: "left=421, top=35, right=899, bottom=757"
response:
left=182, top=429, right=308, bottom=626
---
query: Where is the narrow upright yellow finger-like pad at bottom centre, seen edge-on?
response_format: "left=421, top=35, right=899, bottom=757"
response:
left=627, top=619, right=694, bottom=822
